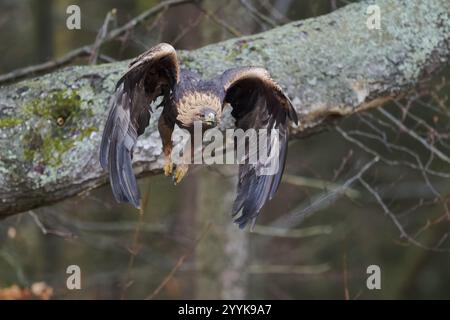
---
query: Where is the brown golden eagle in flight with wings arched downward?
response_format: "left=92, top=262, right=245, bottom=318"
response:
left=100, top=43, right=298, bottom=228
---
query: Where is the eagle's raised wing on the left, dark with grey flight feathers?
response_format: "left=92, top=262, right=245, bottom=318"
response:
left=100, top=43, right=179, bottom=208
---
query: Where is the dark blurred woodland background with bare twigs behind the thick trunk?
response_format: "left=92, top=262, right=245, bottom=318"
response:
left=0, top=0, right=450, bottom=299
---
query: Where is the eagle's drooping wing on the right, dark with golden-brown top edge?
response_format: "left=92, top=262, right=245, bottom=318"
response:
left=220, top=67, right=298, bottom=228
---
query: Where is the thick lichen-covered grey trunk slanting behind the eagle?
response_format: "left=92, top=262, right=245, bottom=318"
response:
left=0, top=0, right=450, bottom=216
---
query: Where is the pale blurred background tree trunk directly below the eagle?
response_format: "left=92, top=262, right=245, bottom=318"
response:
left=195, top=170, right=248, bottom=299
